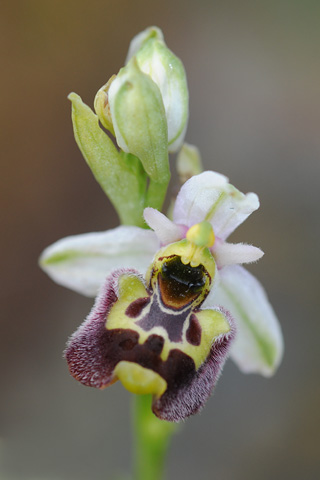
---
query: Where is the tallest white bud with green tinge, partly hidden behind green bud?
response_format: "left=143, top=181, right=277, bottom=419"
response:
left=126, top=27, right=189, bottom=152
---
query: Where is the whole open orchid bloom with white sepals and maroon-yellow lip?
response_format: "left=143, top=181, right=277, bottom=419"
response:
left=40, top=171, right=283, bottom=421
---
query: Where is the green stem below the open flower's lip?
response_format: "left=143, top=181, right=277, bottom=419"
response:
left=134, top=395, right=176, bottom=480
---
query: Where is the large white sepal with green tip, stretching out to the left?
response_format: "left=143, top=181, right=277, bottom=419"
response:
left=40, top=226, right=159, bottom=297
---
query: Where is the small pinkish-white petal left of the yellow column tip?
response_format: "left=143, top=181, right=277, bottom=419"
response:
left=143, top=207, right=184, bottom=245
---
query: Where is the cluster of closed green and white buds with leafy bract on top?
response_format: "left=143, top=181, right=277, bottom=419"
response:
left=69, top=27, right=188, bottom=226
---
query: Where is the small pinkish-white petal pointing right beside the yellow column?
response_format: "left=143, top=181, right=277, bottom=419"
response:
left=212, top=241, right=264, bottom=268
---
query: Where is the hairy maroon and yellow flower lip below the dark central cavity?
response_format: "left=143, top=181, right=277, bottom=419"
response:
left=65, top=269, right=235, bottom=422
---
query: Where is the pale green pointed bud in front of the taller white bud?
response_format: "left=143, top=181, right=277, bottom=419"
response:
left=108, top=57, right=170, bottom=183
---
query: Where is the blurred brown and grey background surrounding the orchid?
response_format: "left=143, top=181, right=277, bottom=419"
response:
left=0, top=0, right=320, bottom=480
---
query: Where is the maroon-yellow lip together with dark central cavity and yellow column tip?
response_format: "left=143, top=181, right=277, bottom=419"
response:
left=65, top=222, right=235, bottom=422
